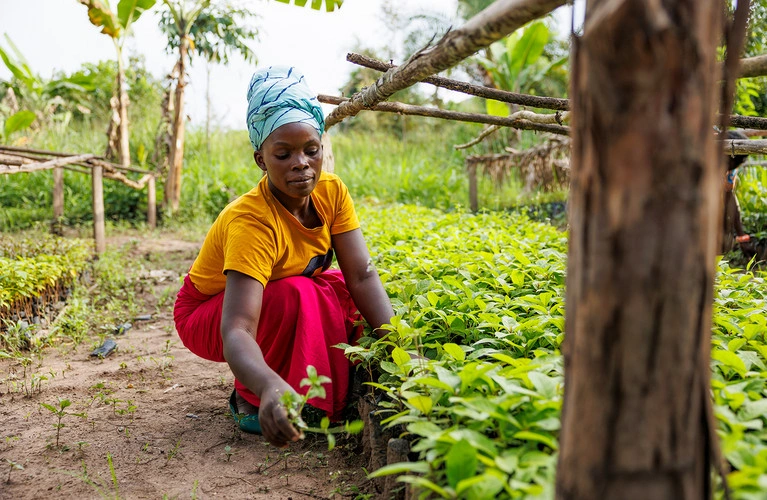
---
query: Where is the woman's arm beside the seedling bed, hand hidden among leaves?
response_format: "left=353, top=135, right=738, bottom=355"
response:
left=333, top=229, right=394, bottom=330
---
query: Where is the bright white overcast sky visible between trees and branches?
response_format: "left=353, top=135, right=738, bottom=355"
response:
left=0, top=0, right=570, bottom=129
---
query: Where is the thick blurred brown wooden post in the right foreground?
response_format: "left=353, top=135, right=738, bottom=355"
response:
left=556, top=0, right=724, bottom=500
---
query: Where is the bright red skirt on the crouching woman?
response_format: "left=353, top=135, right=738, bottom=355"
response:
left=173, top=269, right=362, bottom=420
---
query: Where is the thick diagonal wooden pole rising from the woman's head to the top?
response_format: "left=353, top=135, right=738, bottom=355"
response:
left=325, top=0, right=566, bottom=128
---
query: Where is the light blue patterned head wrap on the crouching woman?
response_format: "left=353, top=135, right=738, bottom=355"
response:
left=247, top=66, right=325, bottom=150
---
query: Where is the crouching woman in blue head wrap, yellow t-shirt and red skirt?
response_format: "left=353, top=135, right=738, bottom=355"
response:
left=174, top=66, right=393, bottom=447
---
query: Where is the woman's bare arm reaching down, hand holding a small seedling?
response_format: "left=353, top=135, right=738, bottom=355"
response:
left=221, top=271, right=300, bottom=447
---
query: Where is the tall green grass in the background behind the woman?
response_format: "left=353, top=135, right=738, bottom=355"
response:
left=0, top=109, right=568, bottom=230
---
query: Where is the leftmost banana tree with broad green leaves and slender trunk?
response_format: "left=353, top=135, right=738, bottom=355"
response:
left=78, top=0, right=157, bottom=166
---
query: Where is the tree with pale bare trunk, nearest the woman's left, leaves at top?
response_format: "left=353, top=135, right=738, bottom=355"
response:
left=163, top=0, right=343, bottom=212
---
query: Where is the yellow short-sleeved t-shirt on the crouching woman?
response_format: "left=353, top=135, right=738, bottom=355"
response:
left=189, top=172, right=360, bottom=295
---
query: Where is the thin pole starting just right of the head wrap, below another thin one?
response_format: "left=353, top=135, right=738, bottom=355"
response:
left=317, top=94, right=569, bottom=135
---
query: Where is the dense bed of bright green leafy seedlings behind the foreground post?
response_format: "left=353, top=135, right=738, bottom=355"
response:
left=352, top=205, right=767, bottom=499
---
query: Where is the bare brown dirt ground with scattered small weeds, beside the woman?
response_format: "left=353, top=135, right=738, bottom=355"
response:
left=0, top=237, right=370, bottom=500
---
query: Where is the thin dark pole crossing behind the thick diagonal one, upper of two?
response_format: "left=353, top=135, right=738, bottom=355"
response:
left=346, top=52, right=570, bottom=111
